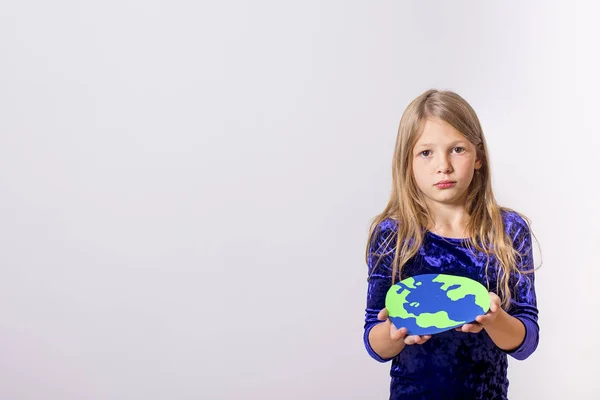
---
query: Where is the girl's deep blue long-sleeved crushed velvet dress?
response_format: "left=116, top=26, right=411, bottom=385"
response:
left=364, top=211, right=539, bottom=400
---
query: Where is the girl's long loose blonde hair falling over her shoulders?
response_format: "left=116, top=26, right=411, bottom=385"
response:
left=367, top=89, right=530, bottom=308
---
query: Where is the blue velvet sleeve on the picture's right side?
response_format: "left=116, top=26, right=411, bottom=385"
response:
left=506, top=216, right=540, bottom=360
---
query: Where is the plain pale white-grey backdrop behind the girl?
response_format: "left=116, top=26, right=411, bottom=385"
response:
left=0, top=0, right=600, bottom=400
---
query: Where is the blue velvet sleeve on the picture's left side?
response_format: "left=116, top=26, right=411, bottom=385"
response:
left=363, top=224, right=395, bottom=362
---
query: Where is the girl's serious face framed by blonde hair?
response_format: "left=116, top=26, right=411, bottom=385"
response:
left=411, top=118, right=482, bottom=207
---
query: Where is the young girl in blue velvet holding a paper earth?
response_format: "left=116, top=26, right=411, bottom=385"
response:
left=364, top=90, right=539, bottom=400
